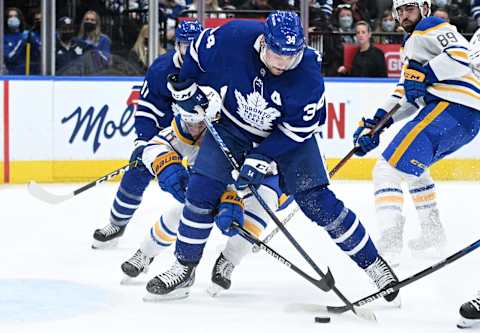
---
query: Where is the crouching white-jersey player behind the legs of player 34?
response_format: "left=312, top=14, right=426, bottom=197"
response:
left=121, top=87, right=290, bottom=296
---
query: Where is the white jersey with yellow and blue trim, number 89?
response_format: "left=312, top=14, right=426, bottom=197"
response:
left=383, top=16, right=480, bottom=121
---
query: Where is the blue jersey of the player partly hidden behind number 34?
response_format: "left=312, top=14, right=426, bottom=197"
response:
left=135, top=50, right=181, bottom=141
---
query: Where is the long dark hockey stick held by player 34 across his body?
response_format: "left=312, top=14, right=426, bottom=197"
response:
left=203, top=114, right=375, bottom=319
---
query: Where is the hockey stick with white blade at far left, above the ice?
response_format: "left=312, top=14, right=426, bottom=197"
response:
left=27, top=161, right=137, bottom=205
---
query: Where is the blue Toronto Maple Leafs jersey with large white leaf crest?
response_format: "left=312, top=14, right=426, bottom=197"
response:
left=180, top=21, right=325, bottom=158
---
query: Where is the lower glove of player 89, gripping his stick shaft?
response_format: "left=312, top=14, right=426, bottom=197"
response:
left=353, top=109, right=393, bottom=156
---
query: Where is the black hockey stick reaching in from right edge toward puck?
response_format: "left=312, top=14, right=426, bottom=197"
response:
left=324, top=239, right=480, bottom=313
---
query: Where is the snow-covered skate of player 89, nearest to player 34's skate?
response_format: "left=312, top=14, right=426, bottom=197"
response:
left=375, top=217, right=405, bottom=267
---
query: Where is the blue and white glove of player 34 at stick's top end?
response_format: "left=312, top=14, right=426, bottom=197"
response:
left=167, top=74, right=208, bottom=113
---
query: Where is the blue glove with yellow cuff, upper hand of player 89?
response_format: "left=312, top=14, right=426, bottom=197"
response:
left=403, top=60, right=438, bottom=105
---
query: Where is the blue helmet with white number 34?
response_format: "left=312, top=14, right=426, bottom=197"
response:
left=264, top=11, right=305, bottom=56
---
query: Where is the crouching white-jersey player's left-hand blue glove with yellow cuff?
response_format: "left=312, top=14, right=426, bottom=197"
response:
left=152, top=151, right=188, bottom=203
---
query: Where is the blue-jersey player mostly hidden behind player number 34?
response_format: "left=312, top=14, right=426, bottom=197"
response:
left=92, top=21, right=202, bottom=249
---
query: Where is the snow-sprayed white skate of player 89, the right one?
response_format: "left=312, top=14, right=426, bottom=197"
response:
left=408, top=209, right=447, bottom=258
